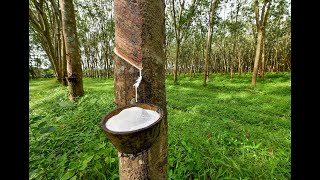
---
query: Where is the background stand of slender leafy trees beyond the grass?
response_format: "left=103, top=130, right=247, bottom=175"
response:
left=29, top=0, right=291, bottom=82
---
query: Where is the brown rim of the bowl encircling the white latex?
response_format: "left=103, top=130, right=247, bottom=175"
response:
left=100, top=103, right=163, bottom=135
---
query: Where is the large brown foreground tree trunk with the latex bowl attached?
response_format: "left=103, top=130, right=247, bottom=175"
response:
left=114, top=0, right=168, bottom=180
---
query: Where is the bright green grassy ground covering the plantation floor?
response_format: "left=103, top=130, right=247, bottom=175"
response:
left=29, top=73, right=291, bottom=179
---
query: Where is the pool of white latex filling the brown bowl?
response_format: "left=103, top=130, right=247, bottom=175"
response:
left=106, top=107, right=160, bottom=132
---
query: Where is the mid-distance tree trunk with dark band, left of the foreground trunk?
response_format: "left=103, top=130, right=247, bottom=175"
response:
left=59, top=0, right=84, bottom=101
